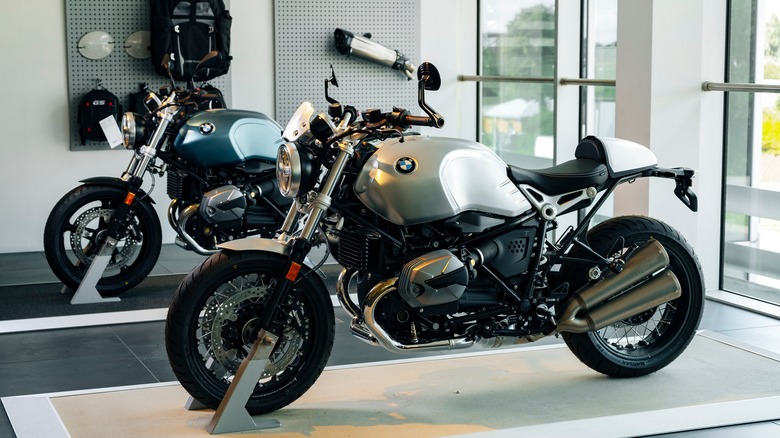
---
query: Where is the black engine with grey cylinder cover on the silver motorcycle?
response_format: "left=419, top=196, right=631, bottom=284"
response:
left=331, top=211, right=536, bottom=315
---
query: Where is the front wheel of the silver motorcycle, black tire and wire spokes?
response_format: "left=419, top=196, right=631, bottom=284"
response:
left=165, top=251, right=335, bottom=415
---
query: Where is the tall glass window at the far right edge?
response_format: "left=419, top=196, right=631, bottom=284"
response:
left=721, top=0, right=780, bottom=304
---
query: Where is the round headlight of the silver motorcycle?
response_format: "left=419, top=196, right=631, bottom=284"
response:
left=276, top=143, right=319, bottom=198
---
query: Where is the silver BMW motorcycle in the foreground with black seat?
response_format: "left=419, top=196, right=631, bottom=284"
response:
left=166, top=63, right=704, bottom=414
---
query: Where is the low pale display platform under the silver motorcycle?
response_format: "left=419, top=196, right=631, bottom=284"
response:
left=2, top=332, right=780, bottom=438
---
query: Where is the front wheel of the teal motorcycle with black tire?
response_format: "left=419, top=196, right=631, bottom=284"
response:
left=43, top=184, right=162, bottom=296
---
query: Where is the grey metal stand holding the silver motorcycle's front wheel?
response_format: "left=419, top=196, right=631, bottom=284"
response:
left=197, top=330, right=281, bottom=435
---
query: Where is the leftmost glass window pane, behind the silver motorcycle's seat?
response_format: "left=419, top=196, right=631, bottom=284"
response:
left=480, top=0, right=555, bottom=168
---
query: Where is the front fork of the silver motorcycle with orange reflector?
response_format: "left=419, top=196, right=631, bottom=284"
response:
left=258, top=142, right=355, bottom=333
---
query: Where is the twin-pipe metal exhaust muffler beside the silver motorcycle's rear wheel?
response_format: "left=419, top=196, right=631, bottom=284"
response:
left=554, top=240, right=682, bottom=333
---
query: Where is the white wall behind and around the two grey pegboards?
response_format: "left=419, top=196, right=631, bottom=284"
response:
left=0, top=0, right=477, bottom=253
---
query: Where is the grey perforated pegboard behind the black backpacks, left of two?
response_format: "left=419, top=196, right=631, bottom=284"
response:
left=65, top=0, right=231, bottom=151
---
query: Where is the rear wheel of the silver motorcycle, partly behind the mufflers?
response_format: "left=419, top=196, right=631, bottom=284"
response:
left=561, top=216, right=704, bottom=377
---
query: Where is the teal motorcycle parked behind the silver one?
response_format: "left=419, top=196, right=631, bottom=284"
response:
left=44, top=54, right=292, bottom=296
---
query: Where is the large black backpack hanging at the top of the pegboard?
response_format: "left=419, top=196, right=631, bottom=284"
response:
left=150, top=0, right=233, bottom=81
